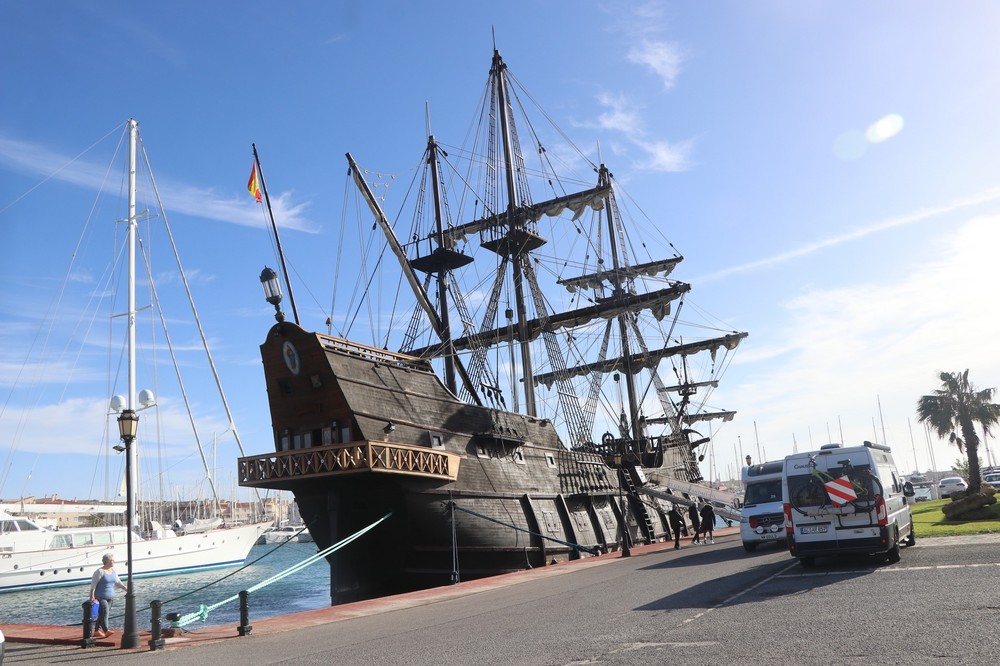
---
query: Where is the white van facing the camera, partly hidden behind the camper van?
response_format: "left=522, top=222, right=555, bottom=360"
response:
left=740, top=460, right=785, bottom=553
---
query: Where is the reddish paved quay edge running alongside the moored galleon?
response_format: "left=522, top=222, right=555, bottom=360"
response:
left=0, top=526, right=740, bottom=652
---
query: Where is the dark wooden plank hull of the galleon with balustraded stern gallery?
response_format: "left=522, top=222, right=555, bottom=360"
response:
left=239, top=322, right=690, bottom=604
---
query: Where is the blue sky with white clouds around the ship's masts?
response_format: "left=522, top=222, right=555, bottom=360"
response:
left=0, top=0, right=1000, bottom=498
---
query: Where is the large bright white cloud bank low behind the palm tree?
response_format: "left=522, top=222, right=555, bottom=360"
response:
left=733, top=217, right=1000, bottom=469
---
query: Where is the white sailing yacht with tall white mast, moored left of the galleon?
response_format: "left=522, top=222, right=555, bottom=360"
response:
left=0, top=119, right=270, bottom=592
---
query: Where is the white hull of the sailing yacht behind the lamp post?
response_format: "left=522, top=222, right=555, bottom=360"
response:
left=0, top=523, right=269, bottom=593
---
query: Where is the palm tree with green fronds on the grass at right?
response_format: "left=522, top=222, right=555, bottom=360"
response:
left=917, top=369, right=1000, bottom=494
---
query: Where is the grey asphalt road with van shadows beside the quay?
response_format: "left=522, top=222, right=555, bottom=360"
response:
left=4, top=536, right=1000, bottom=666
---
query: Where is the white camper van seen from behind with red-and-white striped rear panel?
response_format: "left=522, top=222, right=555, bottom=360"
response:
left=781, top=442, right=916, bottom=567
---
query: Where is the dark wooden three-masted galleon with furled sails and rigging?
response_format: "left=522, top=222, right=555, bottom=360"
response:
left=239, top=49, right=747, bottom=604
